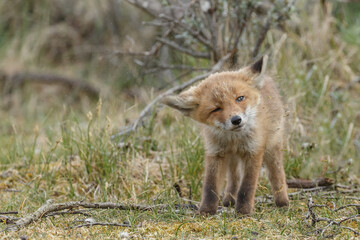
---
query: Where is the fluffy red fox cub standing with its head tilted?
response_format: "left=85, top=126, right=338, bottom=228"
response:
left=163, top=56, right=289, bottom=215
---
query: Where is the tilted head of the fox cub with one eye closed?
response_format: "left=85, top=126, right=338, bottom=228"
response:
left=163, top=56, right=267, bottom=132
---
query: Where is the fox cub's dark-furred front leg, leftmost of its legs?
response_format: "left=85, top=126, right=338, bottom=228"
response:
left=199, top=156, right=226, bottom=215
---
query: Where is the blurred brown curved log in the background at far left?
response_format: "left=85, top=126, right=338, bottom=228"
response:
left=0, top=72, right=100, bottom=98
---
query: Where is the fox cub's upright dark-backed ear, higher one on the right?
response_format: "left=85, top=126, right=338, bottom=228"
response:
left=245, top=55, right=268, bottom=89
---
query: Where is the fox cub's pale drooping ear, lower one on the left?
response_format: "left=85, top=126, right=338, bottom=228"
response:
left=162, top=92, right=198, bottom=116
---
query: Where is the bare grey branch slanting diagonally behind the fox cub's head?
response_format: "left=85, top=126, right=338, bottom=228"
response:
left=111, top=53, right=231, bottom=139
